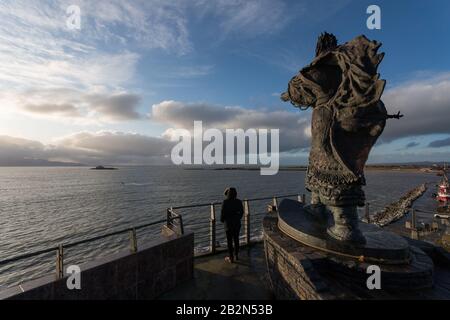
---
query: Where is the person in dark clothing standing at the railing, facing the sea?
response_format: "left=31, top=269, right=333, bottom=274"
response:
left=220, top=188, right=244, bottom=263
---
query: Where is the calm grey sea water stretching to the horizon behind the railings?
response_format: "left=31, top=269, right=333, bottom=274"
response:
left=0, top=167, right=439, bottom=287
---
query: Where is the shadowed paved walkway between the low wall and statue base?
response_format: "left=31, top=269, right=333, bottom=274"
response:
left=160, top=243, right=272, bottom=300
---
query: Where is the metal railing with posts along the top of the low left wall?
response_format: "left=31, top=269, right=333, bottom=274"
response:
left=0, top=213, right=184, bottom=278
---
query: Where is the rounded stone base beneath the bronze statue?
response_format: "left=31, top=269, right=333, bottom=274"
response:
left=263, top=202, right=438, bottom=300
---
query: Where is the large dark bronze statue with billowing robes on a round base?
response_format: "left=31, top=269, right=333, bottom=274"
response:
left=281, top=33, right=402, bottom=244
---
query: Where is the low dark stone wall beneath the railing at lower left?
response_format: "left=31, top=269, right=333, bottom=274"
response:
left=0, top=233, right=194, bottom=300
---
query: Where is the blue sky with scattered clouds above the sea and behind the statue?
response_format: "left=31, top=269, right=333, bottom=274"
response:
left=0, top=0, right=450, bottom=164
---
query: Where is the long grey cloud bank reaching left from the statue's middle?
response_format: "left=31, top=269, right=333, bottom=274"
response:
left=150, top=100, right=310, bottom=151
